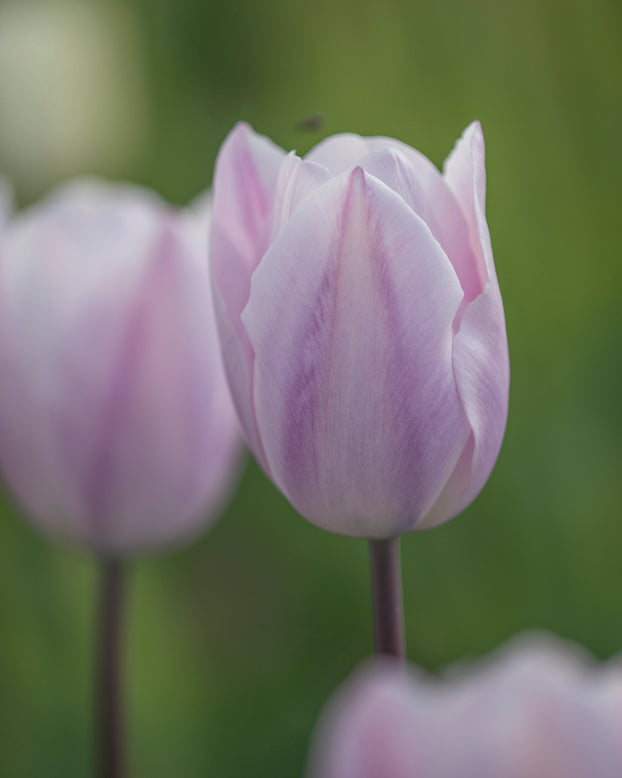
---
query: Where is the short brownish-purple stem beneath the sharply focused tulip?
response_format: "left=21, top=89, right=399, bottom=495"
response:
left=369, top=538, right=406, bottom=659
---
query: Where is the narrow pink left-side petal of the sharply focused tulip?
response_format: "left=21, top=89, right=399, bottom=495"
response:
left=210, top=124, right=285, bottom=467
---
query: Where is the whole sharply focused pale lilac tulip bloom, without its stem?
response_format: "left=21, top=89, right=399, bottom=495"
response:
left=211, top=123, right=509, bottom=538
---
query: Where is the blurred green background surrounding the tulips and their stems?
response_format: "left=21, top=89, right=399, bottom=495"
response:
left=0, top=0, right=622, bottom=778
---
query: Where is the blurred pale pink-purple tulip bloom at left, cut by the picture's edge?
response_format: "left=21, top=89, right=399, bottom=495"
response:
left=0, top=182, right=241, bottom=554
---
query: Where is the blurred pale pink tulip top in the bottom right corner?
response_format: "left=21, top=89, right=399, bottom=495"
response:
left=309, top=636, right=622, bottom=778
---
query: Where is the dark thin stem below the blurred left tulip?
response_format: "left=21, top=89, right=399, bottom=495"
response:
left=96, top=559, right=124, bottom=778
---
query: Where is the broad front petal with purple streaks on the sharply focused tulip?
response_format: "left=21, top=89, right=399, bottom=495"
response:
left=242, top=168, right=469, bottom=538
